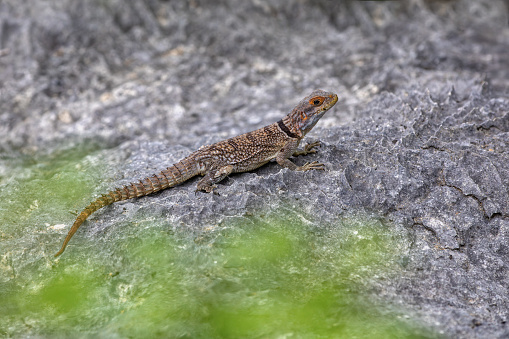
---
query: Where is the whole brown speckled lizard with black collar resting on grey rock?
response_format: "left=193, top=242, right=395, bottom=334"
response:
left=55, top=90, right=338, bottom=257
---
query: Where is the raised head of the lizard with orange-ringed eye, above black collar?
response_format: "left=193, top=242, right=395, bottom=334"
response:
left=288, top=89, right=338, bottom=138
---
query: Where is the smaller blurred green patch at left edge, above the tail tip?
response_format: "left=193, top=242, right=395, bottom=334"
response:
left=0, top=149, right=101, bottom=235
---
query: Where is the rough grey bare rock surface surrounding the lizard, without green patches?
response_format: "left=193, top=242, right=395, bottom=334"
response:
left=0, top=0, right=509, bottom=338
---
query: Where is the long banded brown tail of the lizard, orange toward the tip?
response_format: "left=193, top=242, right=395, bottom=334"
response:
left=55, top=158, right=199, bottom=257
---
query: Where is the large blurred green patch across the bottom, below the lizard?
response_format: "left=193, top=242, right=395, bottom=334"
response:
left=0, top=218, right=432, bottom=338
